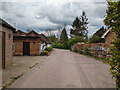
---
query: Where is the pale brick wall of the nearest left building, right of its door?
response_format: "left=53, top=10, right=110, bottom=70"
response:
left=0, top=26, right=13, bottom=67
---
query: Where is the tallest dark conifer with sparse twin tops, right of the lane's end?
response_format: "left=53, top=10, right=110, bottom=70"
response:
left=70, top=11, right=89, bottom=38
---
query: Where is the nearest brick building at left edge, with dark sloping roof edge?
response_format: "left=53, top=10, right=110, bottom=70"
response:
left=0, top=18, right=16, bottom=69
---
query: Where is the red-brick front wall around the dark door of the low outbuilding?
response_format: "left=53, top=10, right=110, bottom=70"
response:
left=14, top=38, right=41, bottom=55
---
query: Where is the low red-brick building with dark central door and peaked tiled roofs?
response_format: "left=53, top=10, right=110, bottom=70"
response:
left=13, top=30, right=49, bottom=55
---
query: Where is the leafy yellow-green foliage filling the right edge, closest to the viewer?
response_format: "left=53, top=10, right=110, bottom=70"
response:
left=104, top=0, right=120, bottom=90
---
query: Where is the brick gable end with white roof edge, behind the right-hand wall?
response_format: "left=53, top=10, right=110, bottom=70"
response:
left=101, top=29, right=116, bottom=45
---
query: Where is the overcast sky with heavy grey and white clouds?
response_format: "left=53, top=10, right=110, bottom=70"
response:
left=0, top=0, right=107, bottom=36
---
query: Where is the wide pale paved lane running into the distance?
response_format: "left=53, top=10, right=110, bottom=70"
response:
left=9, top=49, right=115, bottom=88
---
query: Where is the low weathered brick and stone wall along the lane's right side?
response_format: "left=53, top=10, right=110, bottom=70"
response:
left=72, top=43, right=110, bottom=59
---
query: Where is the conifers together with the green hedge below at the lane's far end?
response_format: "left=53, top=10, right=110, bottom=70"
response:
left=52, top=11, right=88, bottom=49
